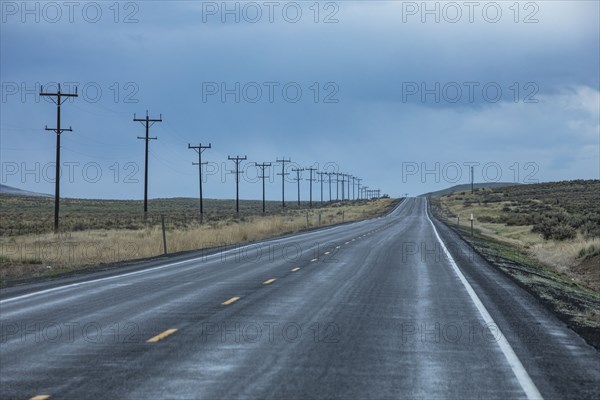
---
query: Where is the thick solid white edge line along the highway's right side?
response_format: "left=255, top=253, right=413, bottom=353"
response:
left=425, top=201, right=543, bottom=399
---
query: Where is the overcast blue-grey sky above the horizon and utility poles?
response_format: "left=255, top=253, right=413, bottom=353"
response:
left=0, top=0, right=600, bottom=200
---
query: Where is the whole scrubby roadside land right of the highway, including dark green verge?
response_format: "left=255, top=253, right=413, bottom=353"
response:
left=432, top=181, right=600, bottom=348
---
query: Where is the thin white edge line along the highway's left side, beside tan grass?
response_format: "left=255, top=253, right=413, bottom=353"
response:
left=0, top=201, right=414, bottom=304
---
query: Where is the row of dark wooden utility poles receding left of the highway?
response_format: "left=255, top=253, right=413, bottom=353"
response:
left=40, top=88, right=381, bottom=233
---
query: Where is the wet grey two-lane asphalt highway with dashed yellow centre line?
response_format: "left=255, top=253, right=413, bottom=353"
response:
left=0, top=198, right=600, bottom=399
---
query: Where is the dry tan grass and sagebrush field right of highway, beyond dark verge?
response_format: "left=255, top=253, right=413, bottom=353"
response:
left=440, top=181, right=600, bottom=291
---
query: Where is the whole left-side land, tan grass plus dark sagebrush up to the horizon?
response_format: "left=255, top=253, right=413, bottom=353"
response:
left=0, top=195, right=395, bottom=284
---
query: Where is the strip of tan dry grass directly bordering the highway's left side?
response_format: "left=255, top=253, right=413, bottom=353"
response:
left=0, top=199, right=394, bottom=283
